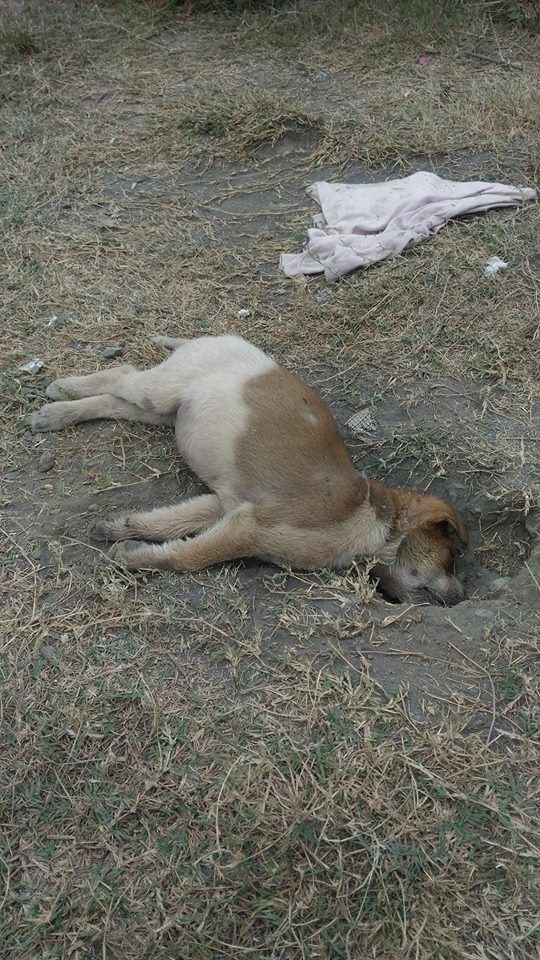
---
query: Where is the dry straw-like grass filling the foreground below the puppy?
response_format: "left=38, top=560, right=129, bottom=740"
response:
left=0, top=556, right=540, bottom=960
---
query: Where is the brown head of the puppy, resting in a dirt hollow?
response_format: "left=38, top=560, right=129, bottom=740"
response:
left=373, top=491, right=469, bottom=606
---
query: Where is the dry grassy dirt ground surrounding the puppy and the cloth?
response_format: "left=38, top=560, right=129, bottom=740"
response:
left=0, top=0, right=540, bottom=960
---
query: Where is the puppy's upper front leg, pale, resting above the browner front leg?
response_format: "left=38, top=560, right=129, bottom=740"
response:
left=91, top=494, right=225, bottom=543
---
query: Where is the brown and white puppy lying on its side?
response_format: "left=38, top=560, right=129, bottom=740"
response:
left=32, top=336, right=468, bottom=605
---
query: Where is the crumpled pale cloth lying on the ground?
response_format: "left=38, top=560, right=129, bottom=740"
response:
left=280, top=172, right=536, bottom=282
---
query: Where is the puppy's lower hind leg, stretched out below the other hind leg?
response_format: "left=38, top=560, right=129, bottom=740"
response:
left=30, top=394, right=174, bottom=433
